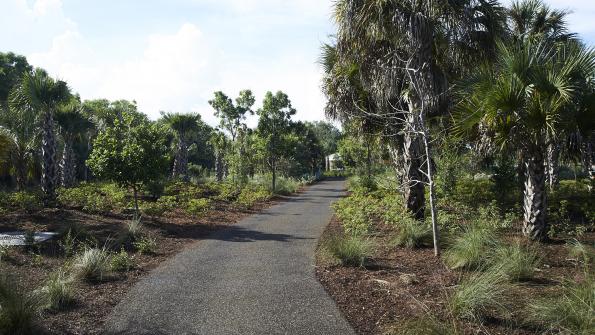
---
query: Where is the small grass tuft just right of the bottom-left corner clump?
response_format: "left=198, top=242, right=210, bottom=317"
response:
left=41, top=269, right=75, bottom=310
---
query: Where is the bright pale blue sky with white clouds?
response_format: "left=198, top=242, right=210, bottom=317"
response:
left=0, top=0, right=595, bottom=125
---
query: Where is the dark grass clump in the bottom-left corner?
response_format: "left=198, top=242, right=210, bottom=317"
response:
left=0, top=275, right=40, bottom=335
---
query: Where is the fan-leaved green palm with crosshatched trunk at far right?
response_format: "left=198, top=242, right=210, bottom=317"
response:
left=457, top=38, right=595, bottom=240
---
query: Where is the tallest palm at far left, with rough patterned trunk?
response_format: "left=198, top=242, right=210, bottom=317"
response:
left=10, top=69, right=70, bottom=205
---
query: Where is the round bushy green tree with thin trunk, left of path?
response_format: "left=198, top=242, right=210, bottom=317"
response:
left=87, top=112, right=168, bottom=214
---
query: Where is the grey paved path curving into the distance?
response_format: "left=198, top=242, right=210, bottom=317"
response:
left=105, top=181, right=355, bottom=335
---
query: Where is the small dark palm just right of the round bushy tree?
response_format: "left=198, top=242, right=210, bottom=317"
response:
left=161, top=113, right=201, bottom=180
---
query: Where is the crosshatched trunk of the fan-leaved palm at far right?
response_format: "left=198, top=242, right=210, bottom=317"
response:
left=523, top=148, right=547, bottom=240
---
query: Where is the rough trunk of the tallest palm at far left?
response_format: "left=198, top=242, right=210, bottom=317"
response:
left=41, top=110, right=56, bottom=205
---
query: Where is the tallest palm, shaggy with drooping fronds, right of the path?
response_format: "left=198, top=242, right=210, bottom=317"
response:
left=323, top=0, right=504, bottom=218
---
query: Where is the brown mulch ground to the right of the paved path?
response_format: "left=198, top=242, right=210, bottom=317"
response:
left=316, top=218, right=595, bottom=335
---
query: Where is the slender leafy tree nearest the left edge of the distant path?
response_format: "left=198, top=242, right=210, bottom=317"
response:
left=256, top=91, right=296, bottom=192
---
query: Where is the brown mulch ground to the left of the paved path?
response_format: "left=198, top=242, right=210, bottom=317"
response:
left=0, top=198, right=282, bottom=334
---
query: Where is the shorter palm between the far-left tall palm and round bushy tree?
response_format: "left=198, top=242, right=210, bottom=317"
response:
left=54, top=100, right=92, bottom=187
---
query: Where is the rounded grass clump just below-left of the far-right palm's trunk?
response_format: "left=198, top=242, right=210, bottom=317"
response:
left=492, top=243, right=540, bottom=281
